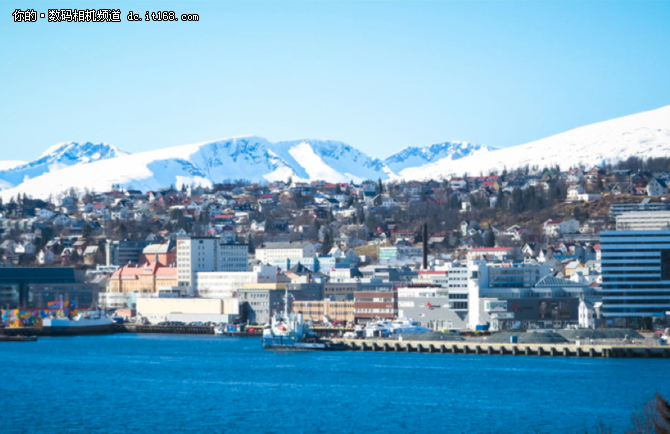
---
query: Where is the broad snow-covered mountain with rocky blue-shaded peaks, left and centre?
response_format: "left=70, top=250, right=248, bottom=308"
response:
left=0, top=136, right=388, bottom=198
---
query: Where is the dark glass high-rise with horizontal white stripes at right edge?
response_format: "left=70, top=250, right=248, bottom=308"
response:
left=600, top=230, right=670, bottom=328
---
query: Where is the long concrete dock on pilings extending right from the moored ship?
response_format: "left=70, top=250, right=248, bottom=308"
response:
left=333, top=339, right=670, bottom=359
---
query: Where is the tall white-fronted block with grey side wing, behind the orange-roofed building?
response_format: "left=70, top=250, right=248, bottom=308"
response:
left=177, top=237, right=249, bottom=295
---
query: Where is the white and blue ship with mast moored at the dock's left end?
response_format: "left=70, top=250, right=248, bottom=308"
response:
left=263, top=289, right=345, bottom=351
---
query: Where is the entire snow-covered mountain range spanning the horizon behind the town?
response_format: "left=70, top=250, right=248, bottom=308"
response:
left=0, top=106, right=670, bottom=200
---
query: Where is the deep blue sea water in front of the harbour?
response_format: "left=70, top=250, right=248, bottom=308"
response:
left=0, top=334, right=670, bottom=434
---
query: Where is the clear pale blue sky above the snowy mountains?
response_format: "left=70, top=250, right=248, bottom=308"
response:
left=0, top=0, right=670, bottom=160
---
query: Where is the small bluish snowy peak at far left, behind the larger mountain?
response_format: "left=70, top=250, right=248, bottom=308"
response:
left=0, top=142, right=127, bottom=190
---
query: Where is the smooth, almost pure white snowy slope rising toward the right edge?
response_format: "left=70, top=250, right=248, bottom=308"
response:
left=399, top=106, right=670, bottom=180
